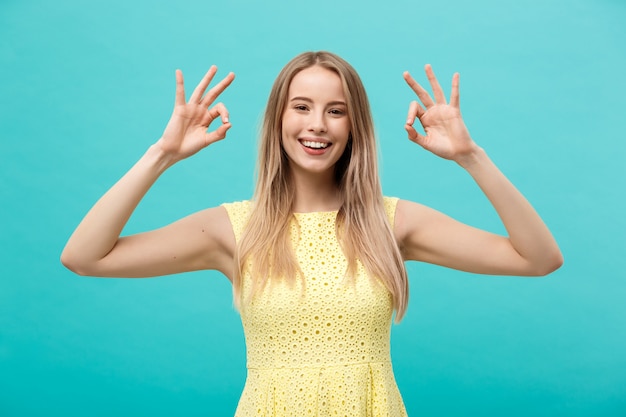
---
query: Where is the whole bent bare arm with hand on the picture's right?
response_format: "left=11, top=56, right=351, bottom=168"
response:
left=396, top=65, right=563, bottom=276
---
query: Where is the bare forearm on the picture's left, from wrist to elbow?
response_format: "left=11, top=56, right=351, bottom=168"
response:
left=61, top=145, right=171, bottom=273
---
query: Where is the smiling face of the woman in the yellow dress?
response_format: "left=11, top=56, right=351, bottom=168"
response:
left=282, top=66, right=350, bottom=177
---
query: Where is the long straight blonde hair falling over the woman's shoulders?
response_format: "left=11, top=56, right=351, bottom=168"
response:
left=233, top=51, right=408, bottom=321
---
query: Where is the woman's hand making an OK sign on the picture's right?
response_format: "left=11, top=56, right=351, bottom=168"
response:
left=403, top=64, right=478, bottom=163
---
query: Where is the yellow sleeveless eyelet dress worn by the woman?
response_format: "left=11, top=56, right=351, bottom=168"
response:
left=223, top=198, right=406, bottom=417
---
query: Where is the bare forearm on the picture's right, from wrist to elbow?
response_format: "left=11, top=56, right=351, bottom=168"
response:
left=457, top=148, right=562, bottom=275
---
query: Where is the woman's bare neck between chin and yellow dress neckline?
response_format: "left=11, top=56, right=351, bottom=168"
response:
left=292, top=168, right=342, bottom=213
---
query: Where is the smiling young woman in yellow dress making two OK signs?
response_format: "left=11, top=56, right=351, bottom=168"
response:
left=62, top=52, right=562, bottom=416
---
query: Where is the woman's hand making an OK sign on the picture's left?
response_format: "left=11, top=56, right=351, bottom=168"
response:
left=157, top=65, right=235, bottom=164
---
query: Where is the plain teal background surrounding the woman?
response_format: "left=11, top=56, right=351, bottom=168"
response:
left=0, top=0, right=626, bottom=417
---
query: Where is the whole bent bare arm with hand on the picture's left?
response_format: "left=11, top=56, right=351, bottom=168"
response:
left=61, top=66, right=234, bottom=277
